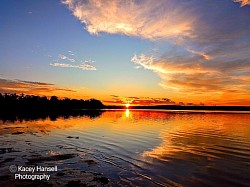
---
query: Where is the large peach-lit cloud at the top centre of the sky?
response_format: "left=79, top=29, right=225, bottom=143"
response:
left=62, top=0, right=193, bottom=39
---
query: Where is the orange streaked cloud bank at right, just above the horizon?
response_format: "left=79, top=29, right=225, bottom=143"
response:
left=131, top=54, right=250, bottom=105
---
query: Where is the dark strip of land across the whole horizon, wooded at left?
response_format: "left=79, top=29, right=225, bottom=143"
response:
left=0, top=93, right=250, bottom=115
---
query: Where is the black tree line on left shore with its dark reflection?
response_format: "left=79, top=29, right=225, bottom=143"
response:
left=0, top=93, right=105, bottom=121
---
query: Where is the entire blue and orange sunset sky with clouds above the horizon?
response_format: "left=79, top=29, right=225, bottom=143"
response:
left=0, top=0, right=250, bottom=106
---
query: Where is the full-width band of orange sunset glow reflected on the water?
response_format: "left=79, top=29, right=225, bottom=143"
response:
left=0, top=109, right=250, bottom=159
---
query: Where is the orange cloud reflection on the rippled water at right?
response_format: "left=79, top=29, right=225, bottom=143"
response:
left=142, top=113, right=250, bottom=161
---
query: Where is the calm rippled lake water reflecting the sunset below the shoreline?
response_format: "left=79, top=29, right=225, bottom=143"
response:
left=0, top=110, right=250, bottom=186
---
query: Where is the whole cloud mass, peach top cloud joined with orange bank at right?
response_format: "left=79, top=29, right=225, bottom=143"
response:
left=62, top=0, right=250, bottom=103
